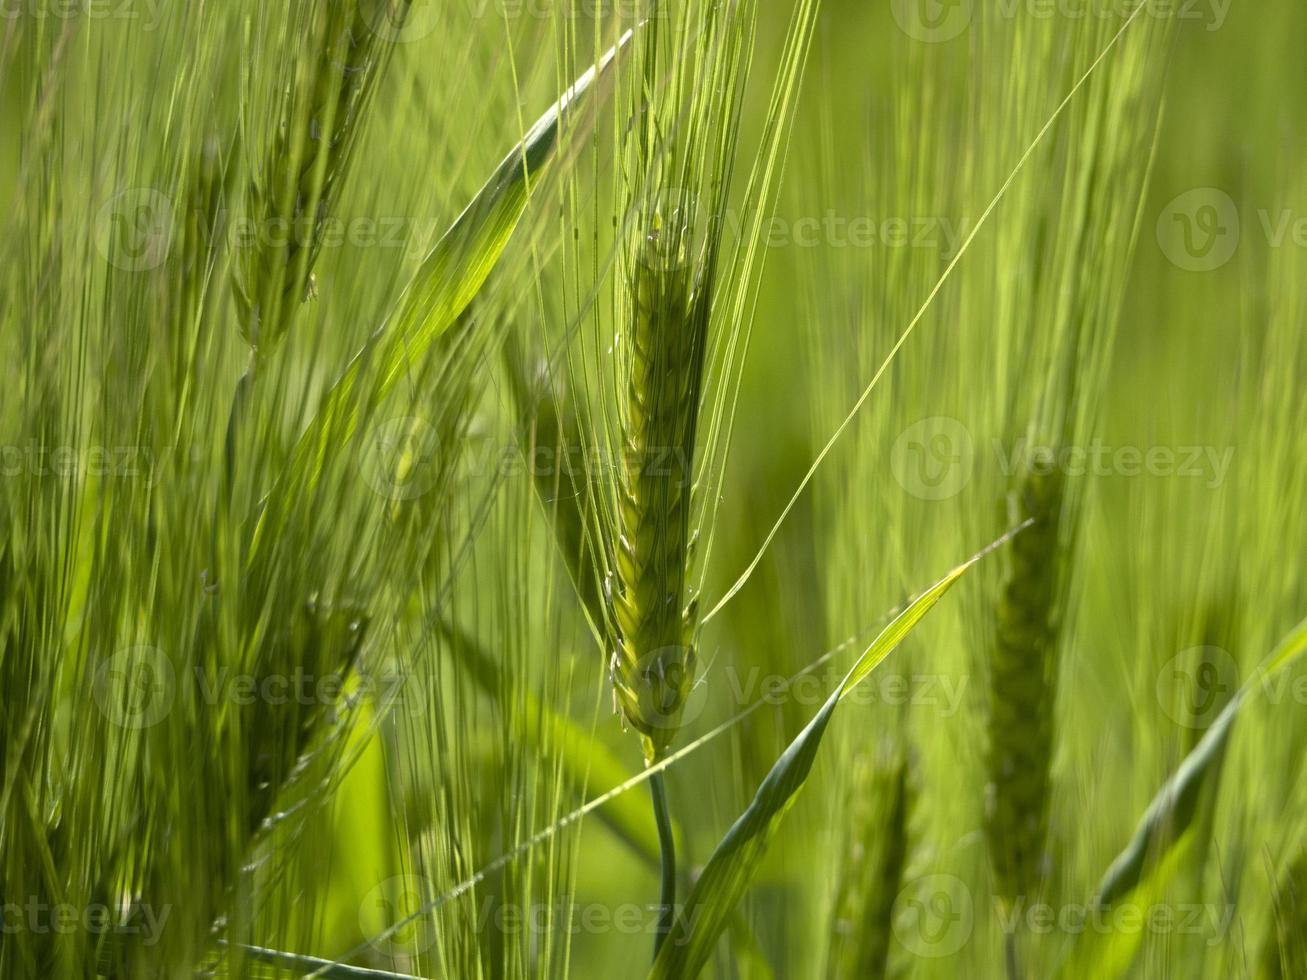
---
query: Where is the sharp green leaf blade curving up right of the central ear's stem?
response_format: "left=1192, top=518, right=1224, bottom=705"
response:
left=650, top=523, right=1029, bottom=980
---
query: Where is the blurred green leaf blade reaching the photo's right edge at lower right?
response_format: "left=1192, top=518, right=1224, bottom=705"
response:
left=1060, top=619, right=1307, bottom=977
